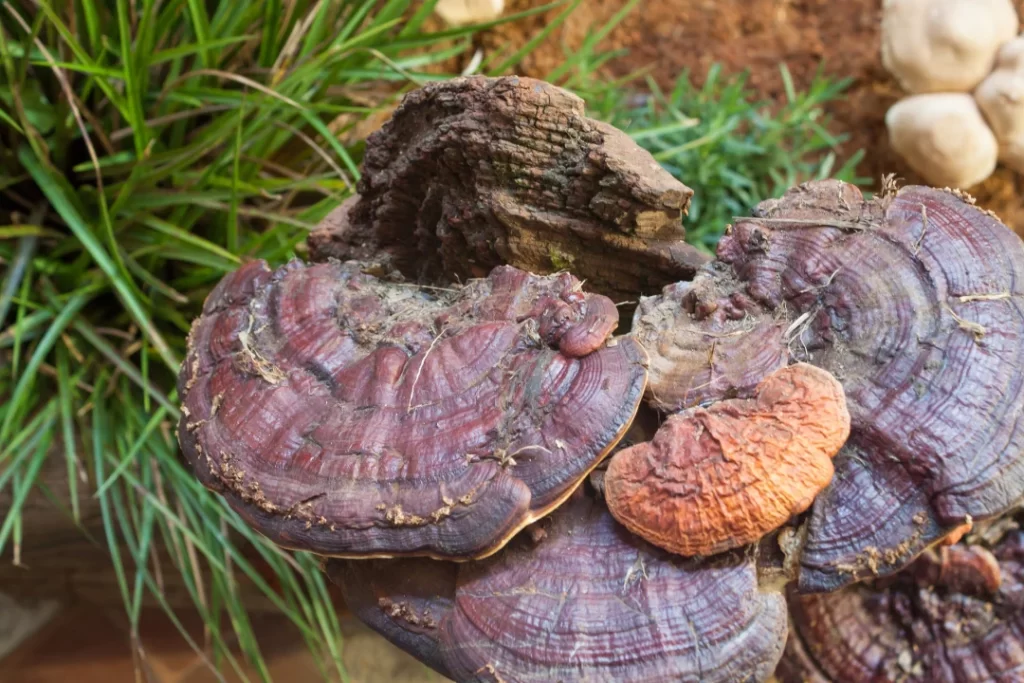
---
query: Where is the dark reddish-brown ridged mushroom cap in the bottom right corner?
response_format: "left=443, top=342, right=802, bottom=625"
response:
left=775, top=520, right=1024, bottom=683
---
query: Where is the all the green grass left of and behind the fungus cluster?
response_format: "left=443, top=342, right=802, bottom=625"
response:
left=0, top=0, right=849, bottom=680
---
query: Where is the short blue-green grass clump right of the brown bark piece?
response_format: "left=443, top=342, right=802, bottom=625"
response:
left=581, top=65, right=865, bottom=251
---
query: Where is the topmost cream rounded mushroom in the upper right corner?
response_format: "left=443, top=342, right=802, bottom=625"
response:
left=882, top=0, right=1020, bottom=93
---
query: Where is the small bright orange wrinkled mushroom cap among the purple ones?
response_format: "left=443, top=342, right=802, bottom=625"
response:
left=604, top=364, right=850, bottom=556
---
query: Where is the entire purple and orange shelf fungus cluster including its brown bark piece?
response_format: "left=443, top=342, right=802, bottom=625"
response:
left=179, top=78, right=1024, bottom=683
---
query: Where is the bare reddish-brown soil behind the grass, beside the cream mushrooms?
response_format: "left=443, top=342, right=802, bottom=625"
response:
left=483, top=0, right=1024, bottom=234
